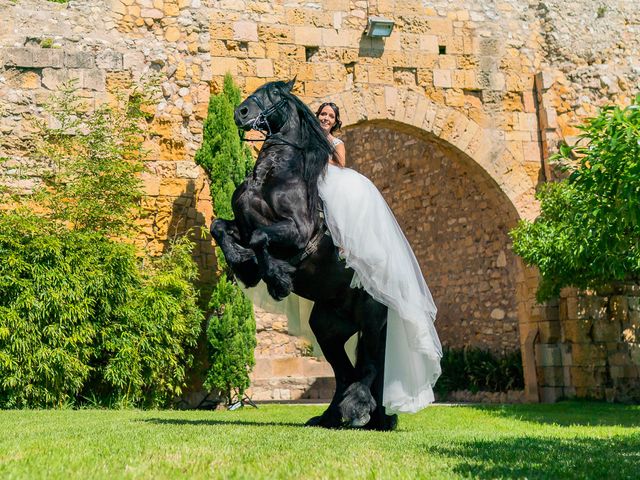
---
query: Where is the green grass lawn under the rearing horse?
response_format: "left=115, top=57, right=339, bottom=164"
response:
left=0, top=403, right=640, bottom=479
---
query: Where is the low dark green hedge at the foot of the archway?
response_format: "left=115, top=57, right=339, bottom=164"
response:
left=435, top=348, right=524, bottom=395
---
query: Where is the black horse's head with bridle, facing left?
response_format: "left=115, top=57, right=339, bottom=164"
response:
left=233, top=78, right=295, bottom=134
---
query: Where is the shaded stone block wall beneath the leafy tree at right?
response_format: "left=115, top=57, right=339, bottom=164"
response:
left=535, top=285, right=640, bottom=403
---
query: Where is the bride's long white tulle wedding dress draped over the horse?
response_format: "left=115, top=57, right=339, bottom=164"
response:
left=242, top=138, right=442, bottom=413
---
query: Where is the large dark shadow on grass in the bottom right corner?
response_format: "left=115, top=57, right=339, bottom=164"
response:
left=424, top=434, right=640, bottom=480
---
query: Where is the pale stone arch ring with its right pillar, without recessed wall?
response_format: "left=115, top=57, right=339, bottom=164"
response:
left=312, top=86, right=538, bottom=401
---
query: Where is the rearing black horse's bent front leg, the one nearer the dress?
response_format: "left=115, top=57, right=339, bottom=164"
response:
left=249, top=219, right=312, bottom=300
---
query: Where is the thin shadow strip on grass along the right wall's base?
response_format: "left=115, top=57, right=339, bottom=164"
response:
left=468, top=401, right=640, bottom=428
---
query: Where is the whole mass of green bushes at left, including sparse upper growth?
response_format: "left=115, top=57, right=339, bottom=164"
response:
left=0, top=80, right=203, bottom=408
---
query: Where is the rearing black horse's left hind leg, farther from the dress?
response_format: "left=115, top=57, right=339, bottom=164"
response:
left=307, top=302, right=357, bottom=428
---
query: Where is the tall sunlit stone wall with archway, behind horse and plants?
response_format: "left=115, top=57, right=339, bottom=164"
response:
left=0, top=0, right=640, bottom=399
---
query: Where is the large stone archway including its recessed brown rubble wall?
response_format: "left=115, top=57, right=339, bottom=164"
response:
left=312, top=86, right=538, bottom=401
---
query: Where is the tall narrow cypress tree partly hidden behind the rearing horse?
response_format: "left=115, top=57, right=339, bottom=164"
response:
left=195, top=75, right=256, bottom=404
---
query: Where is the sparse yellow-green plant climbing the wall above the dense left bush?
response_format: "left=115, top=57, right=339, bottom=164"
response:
left=34, top=83, right=145, bottom=235
